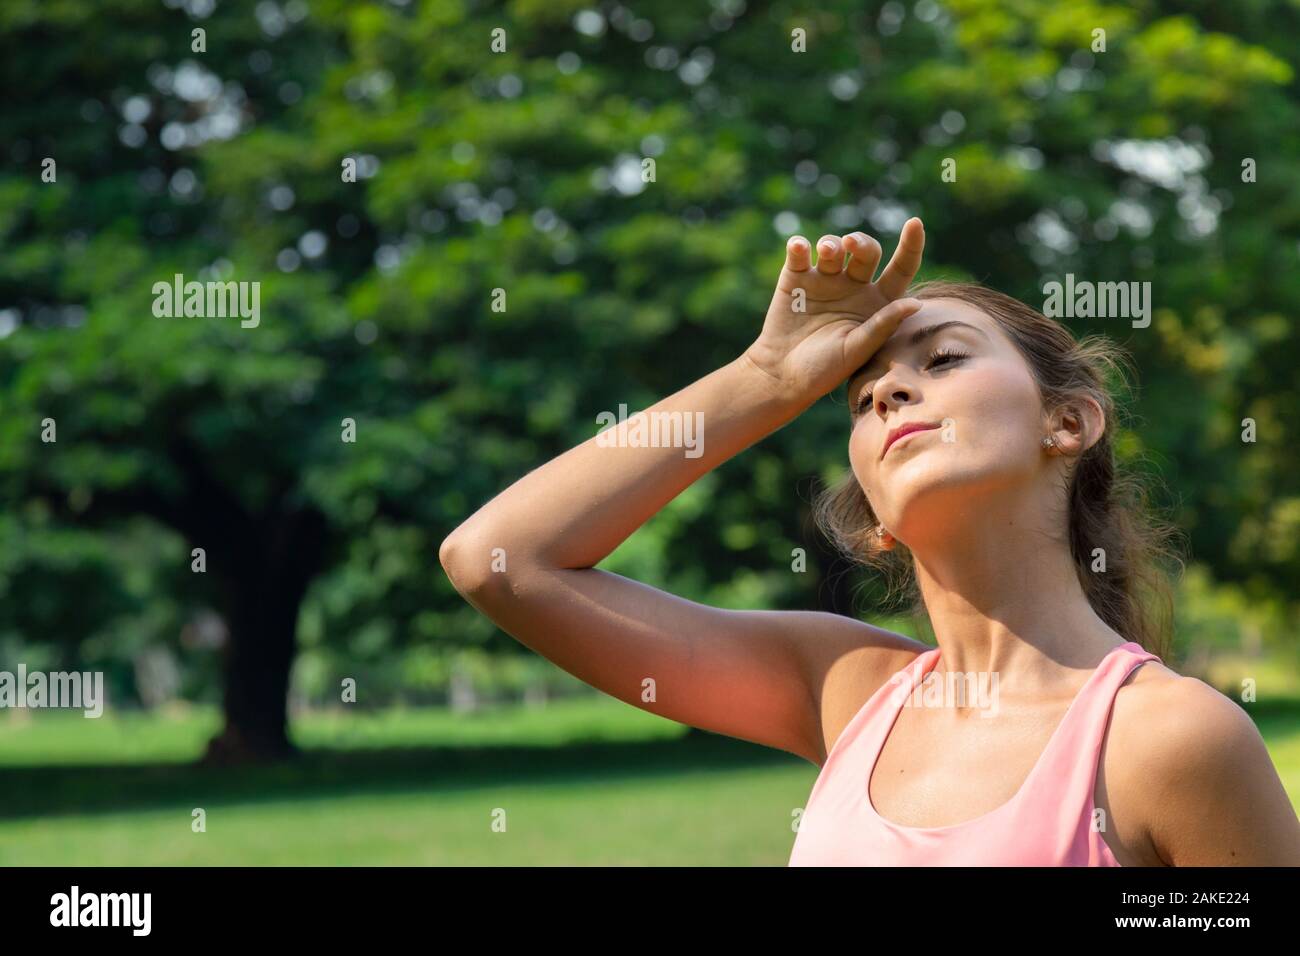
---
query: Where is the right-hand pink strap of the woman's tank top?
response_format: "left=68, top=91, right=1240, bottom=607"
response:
left=1023, top=641, right=1160, bottom=814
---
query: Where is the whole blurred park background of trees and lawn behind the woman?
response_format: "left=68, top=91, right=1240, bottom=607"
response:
left=0, top=0, right=1300, bottom=865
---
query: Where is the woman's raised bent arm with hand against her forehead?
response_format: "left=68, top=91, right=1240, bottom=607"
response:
left=439, top=220, right=922, bottom=762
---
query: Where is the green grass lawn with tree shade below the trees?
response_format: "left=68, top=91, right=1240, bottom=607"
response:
left=0, top=697, right=1300, bottom=866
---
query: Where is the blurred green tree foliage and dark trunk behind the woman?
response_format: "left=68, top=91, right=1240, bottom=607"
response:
left=0, top=0, right=1300, bottom=758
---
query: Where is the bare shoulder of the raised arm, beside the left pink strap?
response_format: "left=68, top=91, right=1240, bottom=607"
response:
left=785, top=613, right=932, bottom=766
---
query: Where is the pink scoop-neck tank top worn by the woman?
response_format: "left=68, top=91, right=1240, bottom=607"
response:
left=789, top=641, right=1160, bottom=866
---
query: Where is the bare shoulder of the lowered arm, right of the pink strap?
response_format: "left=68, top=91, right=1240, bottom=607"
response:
left=1106, top=661, right=1300, bottom=866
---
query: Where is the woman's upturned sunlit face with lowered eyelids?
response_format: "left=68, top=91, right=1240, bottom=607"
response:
left=849, top=299, right=1049, bottom=544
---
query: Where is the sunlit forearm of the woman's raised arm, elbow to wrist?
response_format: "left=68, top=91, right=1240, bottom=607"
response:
left=443, top=356, right=811, bottom=572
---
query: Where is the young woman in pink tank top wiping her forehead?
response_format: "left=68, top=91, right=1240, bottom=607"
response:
left=439, top=220, right=1300, bottom=866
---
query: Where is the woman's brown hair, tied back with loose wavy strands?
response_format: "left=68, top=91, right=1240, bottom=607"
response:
left=813, top=281, right=1183, bottom=658
